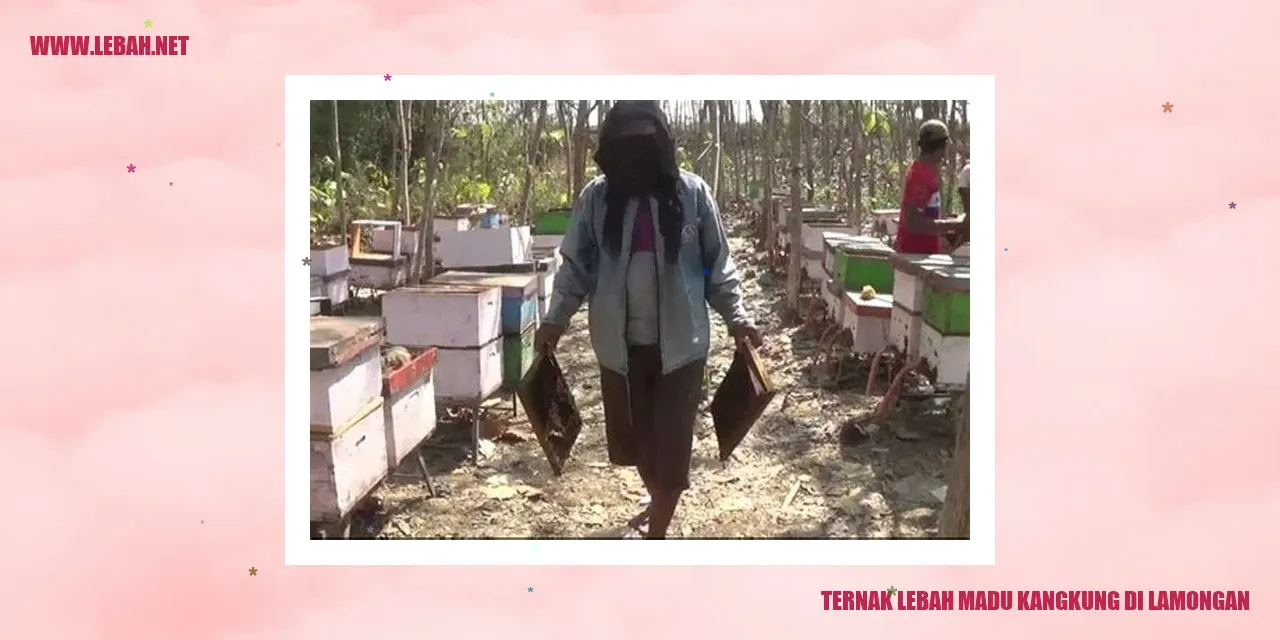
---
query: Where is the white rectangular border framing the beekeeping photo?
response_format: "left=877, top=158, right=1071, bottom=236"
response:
left=284, top=74, right=998, bottom=566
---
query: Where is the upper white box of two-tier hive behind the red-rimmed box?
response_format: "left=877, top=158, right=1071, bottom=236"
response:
left=383, top=284, right=502, bottom=348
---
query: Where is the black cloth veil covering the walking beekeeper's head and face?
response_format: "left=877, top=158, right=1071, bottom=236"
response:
left=595, top=100, right=685, bottom=262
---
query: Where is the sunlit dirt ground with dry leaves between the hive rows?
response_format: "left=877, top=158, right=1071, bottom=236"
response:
left=352, top=217, right=952, bottom=539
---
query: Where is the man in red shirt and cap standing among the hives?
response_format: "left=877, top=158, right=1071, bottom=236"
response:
left=895, top=120, right=964, bottom=253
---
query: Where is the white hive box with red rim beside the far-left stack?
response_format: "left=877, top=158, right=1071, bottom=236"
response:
left=383, top=348, right=436, bottom=468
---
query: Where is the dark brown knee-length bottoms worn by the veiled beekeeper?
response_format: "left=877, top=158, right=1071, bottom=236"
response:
left=600, top=344, right=707, bottom=492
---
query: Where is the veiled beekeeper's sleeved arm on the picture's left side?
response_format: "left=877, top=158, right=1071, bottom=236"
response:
left=543, top=182, right=599, bottom=326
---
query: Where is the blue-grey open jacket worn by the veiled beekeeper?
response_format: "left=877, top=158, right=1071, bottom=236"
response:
left=544, top=172, right=750, bottom=374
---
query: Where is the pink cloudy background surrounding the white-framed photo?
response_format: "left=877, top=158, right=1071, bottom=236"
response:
left=0, top=0, right=1280, bottom=639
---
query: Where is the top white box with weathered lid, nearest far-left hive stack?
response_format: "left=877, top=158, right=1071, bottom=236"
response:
left=311, top=316, right=383, bottom=433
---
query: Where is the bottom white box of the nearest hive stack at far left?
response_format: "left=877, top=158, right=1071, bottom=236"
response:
left=311, top=394, right=388, bottom=522
